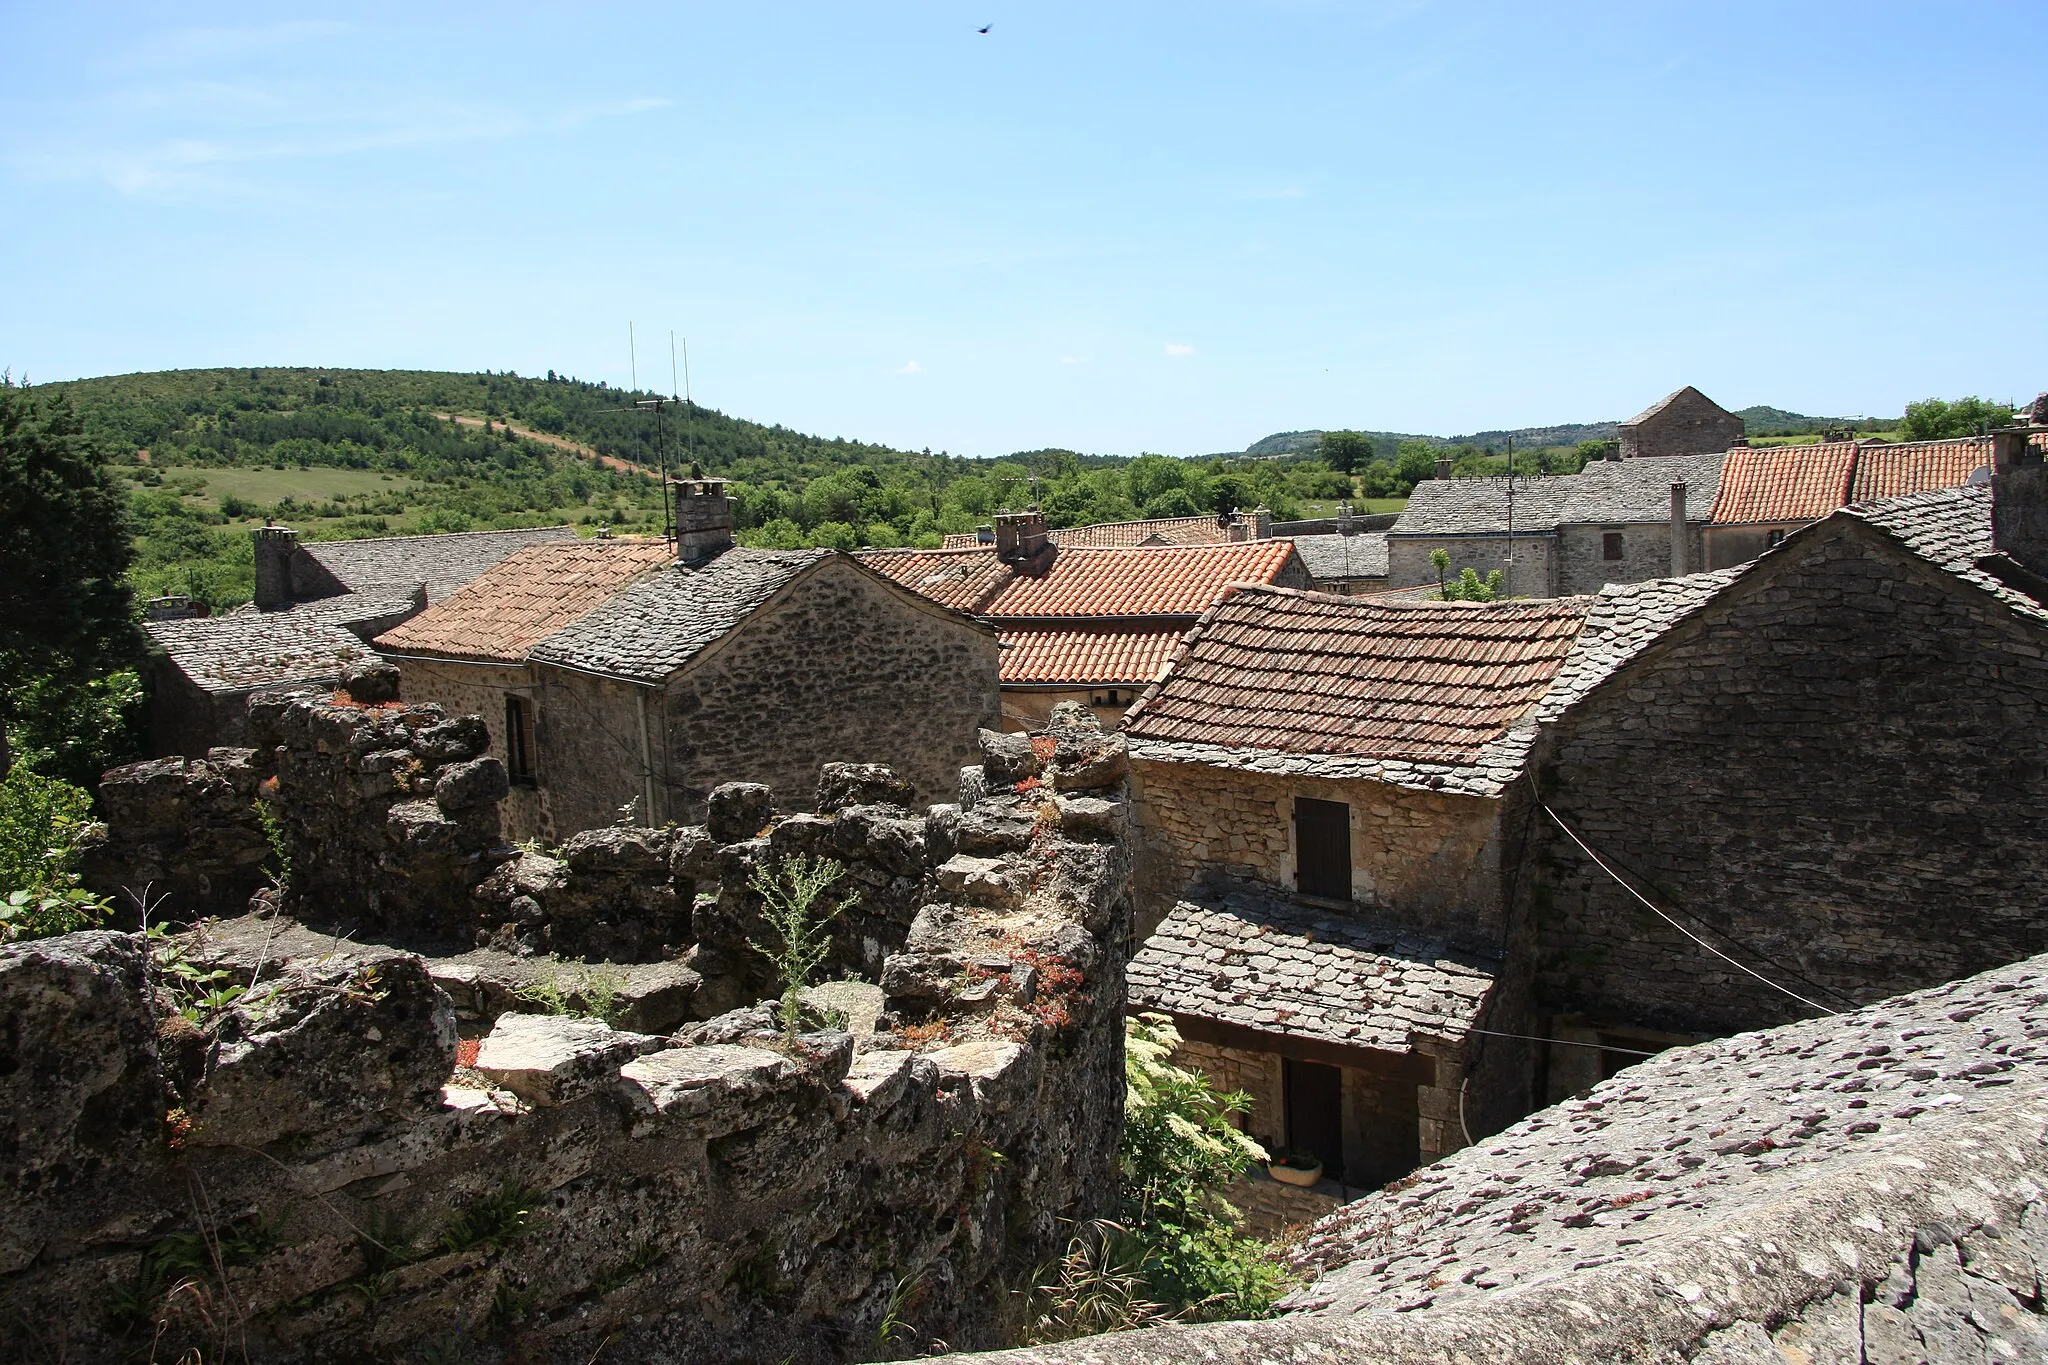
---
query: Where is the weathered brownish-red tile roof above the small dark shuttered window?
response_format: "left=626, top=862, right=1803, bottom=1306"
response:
left=1122, top=587, right=1587, bottom=765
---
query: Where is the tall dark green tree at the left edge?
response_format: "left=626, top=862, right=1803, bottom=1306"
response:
left=0, top=383, right=141, bottom=774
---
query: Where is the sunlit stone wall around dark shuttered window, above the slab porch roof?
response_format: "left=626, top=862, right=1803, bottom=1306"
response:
left=1135, top=759, right=1511, bottom=950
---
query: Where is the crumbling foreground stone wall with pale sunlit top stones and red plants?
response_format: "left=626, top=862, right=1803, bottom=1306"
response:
left=0, top=720, right=1130, bottom=1365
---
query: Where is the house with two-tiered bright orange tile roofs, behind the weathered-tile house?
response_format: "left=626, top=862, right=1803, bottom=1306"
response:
left=858, top=512, right=1311, bottom=731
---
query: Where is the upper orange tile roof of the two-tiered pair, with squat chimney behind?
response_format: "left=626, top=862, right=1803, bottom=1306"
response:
left=858, top=540, right=1298, bottom=620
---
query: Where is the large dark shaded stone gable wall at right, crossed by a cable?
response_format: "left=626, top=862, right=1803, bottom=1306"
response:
left=1524, top=524, right=2048, bottom=1033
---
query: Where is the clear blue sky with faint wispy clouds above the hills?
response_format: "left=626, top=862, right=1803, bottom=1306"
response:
left=0, top=0, right=2048, bottom=454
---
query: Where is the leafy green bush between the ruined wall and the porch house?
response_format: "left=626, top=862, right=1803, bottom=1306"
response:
left=1026, top=1015, right=1288, bottom=1342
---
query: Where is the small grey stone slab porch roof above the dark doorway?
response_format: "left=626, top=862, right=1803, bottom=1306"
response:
left=1130, top=892, right=1495, bottom=1052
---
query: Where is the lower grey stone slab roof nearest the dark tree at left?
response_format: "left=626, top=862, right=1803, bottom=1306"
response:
left=143, top=589, right=426, bottom=692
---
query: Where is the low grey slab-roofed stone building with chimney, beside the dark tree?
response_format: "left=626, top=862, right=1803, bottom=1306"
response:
left=143, top=526, right=575, bottom=755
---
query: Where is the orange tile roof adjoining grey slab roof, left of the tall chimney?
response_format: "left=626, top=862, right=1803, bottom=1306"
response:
left=377, top=540, right=674, bottom=663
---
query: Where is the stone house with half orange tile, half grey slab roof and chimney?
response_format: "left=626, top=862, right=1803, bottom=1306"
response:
left=377, top=479, right=997, bottom=841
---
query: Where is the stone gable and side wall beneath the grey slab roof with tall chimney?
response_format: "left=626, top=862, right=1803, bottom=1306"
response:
left=537, top=563, right=1001, bottom=835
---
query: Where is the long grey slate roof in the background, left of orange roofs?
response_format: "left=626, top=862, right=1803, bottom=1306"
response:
left=1392, top=454, right=1729, bottom=546
